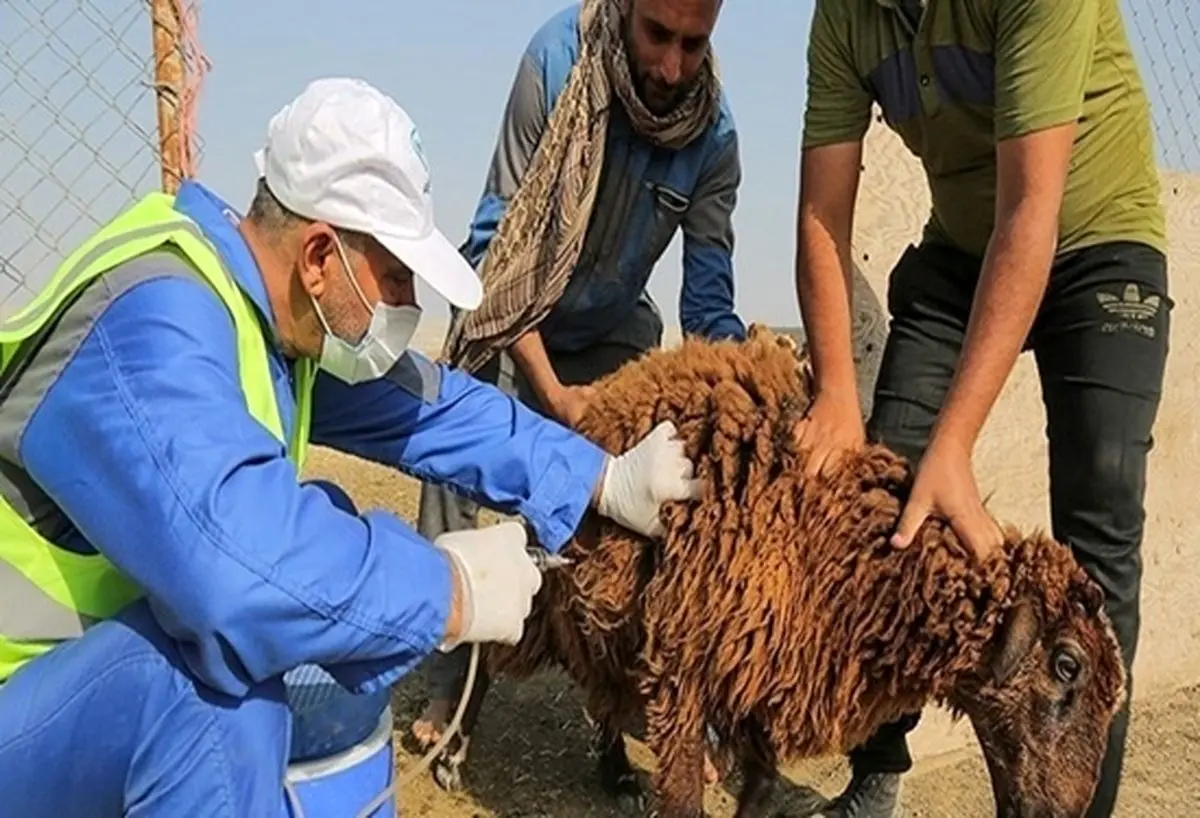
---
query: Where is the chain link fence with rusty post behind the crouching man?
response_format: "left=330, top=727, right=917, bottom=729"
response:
left=0, top=0, right=206, bottom=315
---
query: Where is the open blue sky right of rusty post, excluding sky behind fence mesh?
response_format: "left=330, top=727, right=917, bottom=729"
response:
left=194, top=0, right=811, bottom=323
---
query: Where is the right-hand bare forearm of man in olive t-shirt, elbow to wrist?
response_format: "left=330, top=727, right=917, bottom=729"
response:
left=934, top=205, right=1058, bottom=451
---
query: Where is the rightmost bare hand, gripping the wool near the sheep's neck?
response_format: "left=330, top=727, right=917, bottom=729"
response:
left=892, top=429, right=1004, bottom=561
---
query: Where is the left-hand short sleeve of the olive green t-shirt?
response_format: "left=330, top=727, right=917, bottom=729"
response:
left=802, top=0, right=871, bottom=148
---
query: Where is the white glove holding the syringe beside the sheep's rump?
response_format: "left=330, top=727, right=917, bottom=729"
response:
left=433, top=521, right=541, bottom=651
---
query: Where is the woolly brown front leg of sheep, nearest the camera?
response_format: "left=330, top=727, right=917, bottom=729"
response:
left=646, top=685, right=704, bottom=818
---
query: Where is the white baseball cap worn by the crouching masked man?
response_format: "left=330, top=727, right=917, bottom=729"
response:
left=254, top=77, right=484, bottom=309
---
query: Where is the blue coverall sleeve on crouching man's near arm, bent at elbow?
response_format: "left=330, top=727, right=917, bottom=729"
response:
left=19, top=277, right=451, bottom=696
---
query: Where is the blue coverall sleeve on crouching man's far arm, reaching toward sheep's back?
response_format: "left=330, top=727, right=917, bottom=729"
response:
left=312, top=351, right=606, bottom=552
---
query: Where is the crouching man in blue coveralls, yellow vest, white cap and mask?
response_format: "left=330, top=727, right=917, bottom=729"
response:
left=0, top=79, right=696, bottom=818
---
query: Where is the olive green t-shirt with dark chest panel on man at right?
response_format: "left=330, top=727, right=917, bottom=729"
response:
left=803, top=0, right=1166, bottom=255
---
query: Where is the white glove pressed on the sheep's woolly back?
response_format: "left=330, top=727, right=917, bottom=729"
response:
left=596, top=421, right=700, bottom=537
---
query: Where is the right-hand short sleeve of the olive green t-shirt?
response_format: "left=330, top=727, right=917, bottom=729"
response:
left=995, top=0, right=1099, bottom=140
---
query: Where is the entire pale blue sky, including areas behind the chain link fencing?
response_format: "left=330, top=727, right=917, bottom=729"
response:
left=0, top=0, right=1200, bottom=323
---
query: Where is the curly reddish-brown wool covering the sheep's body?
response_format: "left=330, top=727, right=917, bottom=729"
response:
left=488, top=323, right=1118, bottom=777
